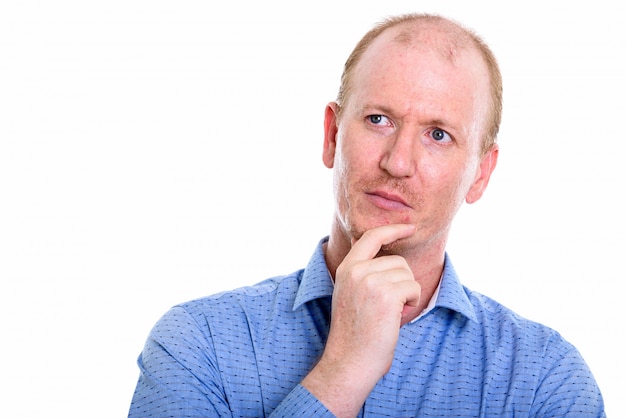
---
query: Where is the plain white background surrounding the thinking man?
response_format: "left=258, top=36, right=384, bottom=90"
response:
left=0, top=0, right=626, bottom=417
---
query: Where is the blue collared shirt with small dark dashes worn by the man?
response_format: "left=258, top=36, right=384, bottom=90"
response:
left=129, top=240, right=605, bottom=418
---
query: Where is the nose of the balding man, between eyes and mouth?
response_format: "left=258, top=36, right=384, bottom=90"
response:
left=380, top=129, right=417, bottom=178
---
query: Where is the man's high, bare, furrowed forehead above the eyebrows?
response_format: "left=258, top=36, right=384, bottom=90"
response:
left=348, top=23, right=490, bottom=136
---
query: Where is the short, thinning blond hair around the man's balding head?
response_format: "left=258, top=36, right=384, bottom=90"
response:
left=337, top=13, right=502, bottom=154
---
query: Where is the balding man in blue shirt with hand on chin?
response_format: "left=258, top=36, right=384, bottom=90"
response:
left=130, top=11, right=604, bottom=417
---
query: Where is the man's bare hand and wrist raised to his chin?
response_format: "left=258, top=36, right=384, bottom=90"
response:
left=302, top=225, right=420, bottom=417
